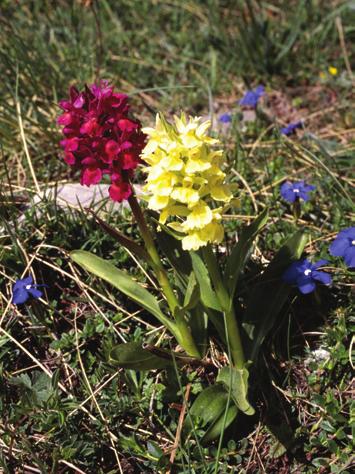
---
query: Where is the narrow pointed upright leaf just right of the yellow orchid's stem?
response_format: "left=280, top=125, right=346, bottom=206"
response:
left=224, top=209, right=268, bottom=298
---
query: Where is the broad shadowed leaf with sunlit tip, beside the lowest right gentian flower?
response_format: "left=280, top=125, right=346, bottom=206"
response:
left=242, top=230, right=307, bottom=361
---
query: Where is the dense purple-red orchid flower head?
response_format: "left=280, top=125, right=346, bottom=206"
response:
left=58, top=81, right=145, bottom=202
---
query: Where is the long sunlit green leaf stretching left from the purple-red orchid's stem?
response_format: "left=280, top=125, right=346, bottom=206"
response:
left=70, top=250, right=175, bottom=334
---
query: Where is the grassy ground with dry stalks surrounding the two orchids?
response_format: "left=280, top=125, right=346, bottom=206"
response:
left=0, top=0, right=355, bottom=474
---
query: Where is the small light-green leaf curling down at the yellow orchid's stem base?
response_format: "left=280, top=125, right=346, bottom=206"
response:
left=217, top=367, right=255, bottom=415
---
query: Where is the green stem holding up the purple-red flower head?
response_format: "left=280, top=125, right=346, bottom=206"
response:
left=128, top=194, right=201, bottom=358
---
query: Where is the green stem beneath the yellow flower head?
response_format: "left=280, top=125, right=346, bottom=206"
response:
left=203, top=245, right=245, bottom=369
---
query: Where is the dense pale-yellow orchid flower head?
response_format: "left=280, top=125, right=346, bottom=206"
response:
left=141, top=114, right=232, bottom=250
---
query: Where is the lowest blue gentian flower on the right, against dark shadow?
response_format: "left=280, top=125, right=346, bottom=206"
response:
left=282, top=259, right=332, bottom=295
